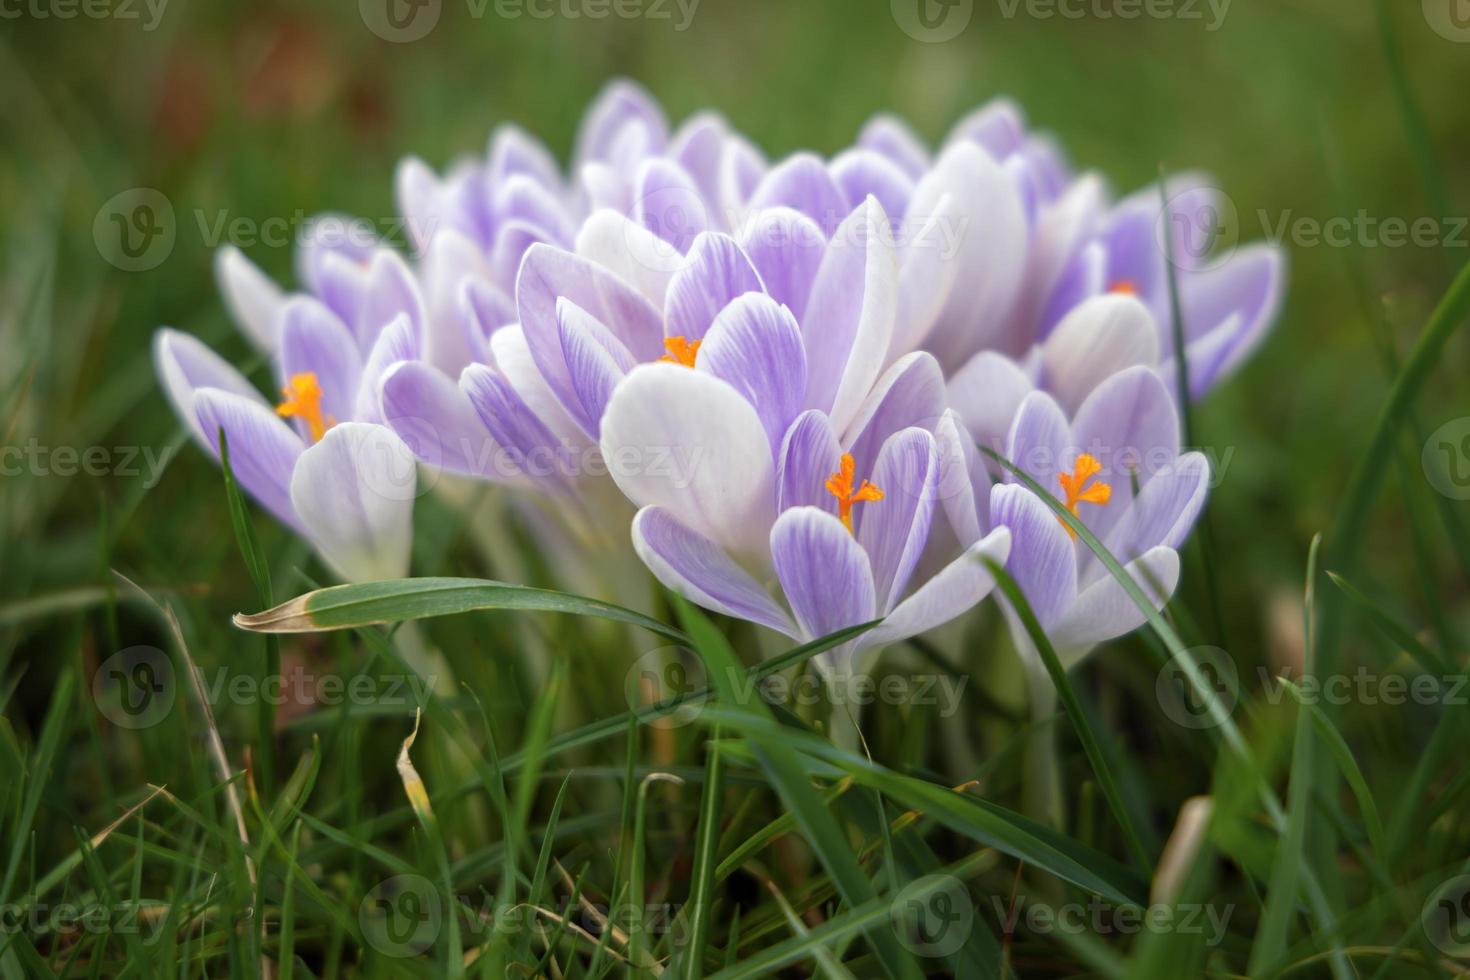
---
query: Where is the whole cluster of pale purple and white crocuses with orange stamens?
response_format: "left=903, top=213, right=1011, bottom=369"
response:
left=156, top=82, right=1283, bottom=693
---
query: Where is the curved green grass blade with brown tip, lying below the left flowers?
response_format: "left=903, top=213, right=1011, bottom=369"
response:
left=235, top=577, right=688, bottom=644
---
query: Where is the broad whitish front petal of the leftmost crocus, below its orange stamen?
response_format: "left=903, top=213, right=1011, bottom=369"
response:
left=291, top=422, right=416, bottom=582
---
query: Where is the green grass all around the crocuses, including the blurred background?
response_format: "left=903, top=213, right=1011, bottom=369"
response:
left=0, top=0, right=1470, bottom=980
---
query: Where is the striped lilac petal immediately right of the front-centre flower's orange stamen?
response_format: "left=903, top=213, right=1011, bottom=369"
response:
left=856, top=429, right=939, bottom=613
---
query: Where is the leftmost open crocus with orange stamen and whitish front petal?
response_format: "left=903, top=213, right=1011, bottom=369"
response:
left=153, top=243, right=423, bottom=580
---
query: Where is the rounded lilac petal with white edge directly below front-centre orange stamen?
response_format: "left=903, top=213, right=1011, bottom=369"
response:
left=770, top=507, right=878, bottom=639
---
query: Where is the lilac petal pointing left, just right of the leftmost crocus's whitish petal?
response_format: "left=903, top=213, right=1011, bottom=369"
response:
left=382, top=361, right=515, bottom=482
